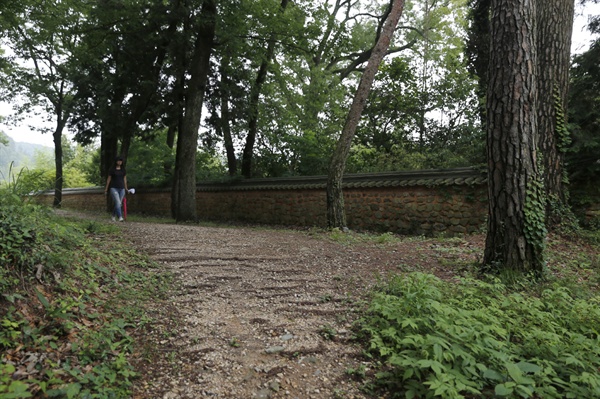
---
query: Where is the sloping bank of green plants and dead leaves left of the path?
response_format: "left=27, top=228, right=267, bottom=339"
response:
left=0, top=193, right=170, bottom=398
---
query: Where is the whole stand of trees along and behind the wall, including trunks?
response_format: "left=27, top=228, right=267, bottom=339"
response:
left=0, top=0, right=600, bottom=272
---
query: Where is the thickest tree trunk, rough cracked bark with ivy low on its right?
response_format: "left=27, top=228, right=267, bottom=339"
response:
left=484, top=0, right=545, bottom=274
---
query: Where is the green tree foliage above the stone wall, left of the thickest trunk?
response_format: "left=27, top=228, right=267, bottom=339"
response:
left=2, top=0, right=483, bottom=184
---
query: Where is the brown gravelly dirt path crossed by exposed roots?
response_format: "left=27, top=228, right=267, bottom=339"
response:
left=123, top=223, right=480, bottom=399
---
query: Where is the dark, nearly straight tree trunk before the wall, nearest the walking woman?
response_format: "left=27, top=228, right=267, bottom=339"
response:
left=171, top=0, right=217, bottom=222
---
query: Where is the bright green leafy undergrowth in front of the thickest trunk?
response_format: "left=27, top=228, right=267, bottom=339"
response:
left=359, top=273, right=600, bottom=398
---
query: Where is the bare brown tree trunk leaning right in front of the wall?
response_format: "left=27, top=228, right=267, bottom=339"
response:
left=327, top=0, right=404, bottom=228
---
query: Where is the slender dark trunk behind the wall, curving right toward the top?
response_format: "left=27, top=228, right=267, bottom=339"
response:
left=242, top=0, right=289, bottom=178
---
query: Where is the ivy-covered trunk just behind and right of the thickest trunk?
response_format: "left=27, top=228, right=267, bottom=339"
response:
left=536, top=0, right=575, bottom=224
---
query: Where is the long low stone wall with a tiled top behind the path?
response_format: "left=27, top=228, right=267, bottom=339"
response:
left=40, top=168, right=487, bottom=234
